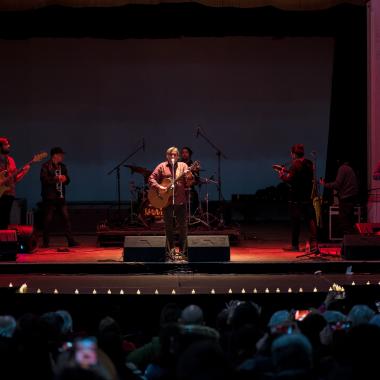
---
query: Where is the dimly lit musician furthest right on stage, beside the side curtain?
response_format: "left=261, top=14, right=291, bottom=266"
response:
left=320, top=160, right=359, bottom=235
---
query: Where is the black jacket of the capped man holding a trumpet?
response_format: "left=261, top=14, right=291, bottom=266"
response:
left=40, top=160, right=70, bottom=200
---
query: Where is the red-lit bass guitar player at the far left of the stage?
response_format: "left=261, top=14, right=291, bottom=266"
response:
left=0, top=137, right=30, bottom=230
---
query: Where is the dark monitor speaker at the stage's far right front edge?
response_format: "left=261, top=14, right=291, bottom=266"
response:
left=342, top=235, right=380, bottom=260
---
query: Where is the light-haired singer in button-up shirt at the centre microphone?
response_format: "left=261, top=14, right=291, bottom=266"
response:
left=149, top=146, right=192, bottom=261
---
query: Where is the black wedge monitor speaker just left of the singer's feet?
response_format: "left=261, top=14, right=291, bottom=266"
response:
left=124, top=236, right=166, bottom=262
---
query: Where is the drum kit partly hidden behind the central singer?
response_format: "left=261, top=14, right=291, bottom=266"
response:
left=124, top=165, right=218, bottom=227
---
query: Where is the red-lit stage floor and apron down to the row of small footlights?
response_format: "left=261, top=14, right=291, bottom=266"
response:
left=0, top=227, right=380, bottom=295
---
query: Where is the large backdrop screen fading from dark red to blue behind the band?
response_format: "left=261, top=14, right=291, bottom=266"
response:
left=0, top=37, right=333, bottom=206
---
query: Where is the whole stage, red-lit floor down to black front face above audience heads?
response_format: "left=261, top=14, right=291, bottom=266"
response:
left=0, top=223, right=380, bottom=329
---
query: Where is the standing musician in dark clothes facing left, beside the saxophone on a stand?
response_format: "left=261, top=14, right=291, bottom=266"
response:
left=279, top=144, right=318, bottom=253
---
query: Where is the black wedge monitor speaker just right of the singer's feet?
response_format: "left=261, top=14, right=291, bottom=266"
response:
left=187, top=235, right=230, bottom=262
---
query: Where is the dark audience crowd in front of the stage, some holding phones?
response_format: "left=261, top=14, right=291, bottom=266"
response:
left=0, top=294, right=380, bottom=380
